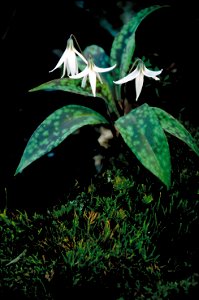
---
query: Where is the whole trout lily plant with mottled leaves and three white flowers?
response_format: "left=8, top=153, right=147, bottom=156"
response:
left=15, top=5, right=199, bottom=188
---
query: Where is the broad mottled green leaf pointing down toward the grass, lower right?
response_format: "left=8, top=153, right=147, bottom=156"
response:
left=115, top=104, right=171, bottom=187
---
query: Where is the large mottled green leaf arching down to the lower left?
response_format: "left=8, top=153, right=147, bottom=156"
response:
left=15, top=105, right=108, bottom=175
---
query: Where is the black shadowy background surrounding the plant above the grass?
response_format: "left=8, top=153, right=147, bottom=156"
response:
left=0, top=0, right=199, bottom=207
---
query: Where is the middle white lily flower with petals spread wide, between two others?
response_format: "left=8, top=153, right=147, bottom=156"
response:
left=69, top=58, right=116, bottom=97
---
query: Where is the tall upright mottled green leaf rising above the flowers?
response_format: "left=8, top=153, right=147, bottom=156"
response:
left=110, top=5, right=166, bottom=99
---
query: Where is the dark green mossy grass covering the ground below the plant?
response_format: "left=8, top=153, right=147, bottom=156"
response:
left=0, top=121, right=199, bottom=300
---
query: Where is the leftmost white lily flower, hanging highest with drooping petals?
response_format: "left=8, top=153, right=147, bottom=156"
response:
left=49, top=37, right=88, bottom=78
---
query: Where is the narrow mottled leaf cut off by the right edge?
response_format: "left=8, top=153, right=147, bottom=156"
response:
left=153, top=107, right=199, bottom=155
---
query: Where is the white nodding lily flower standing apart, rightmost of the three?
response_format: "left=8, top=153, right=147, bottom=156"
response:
left=113, top=59, right=163, bottom=101
